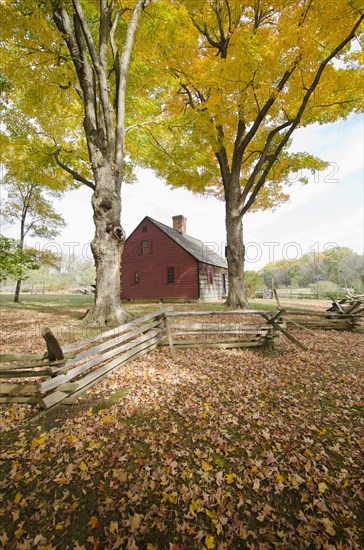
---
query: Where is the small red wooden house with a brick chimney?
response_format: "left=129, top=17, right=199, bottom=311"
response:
left=121, top=216, right=228, bottom=301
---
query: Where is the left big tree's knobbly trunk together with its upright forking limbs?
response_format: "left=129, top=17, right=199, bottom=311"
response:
left=51, top=0, right=150, bottom=325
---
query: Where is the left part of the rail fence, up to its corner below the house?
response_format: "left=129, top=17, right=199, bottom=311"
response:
left=0, top=308, right=168, bottom=409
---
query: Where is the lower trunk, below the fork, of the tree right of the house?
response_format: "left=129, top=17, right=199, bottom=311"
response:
left=225, top=197, right=249, bottom=308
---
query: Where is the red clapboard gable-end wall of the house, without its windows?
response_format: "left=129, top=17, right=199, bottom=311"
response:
left=121, top=219, right=199, bottom=300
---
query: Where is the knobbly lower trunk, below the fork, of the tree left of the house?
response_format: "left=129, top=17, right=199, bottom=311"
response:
left=85, top=161, right=130, bottom=326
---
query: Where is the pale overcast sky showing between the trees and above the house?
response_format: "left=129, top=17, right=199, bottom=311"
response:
left=2, top=116, right=364, bottom=270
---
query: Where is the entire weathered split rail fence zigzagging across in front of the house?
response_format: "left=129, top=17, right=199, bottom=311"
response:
left=0, top=306, right=364, bottom=410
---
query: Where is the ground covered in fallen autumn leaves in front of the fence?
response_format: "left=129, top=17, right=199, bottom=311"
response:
left=0, top=322, right=364, bottom=550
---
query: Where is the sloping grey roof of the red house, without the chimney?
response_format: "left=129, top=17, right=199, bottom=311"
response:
left=145, top=216, right=227, bottom=269
